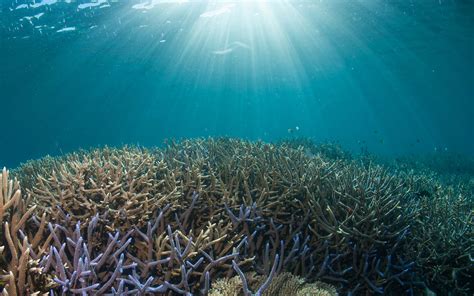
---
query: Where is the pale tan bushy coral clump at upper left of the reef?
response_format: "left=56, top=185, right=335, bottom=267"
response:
left=16, top=148, right=179, bottom=229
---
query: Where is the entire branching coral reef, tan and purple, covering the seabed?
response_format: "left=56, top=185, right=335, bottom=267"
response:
left=0, top=139, right=474, bottom=296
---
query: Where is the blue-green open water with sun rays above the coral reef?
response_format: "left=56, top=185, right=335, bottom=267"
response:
left=0, top=0, right=474, bottom=167
